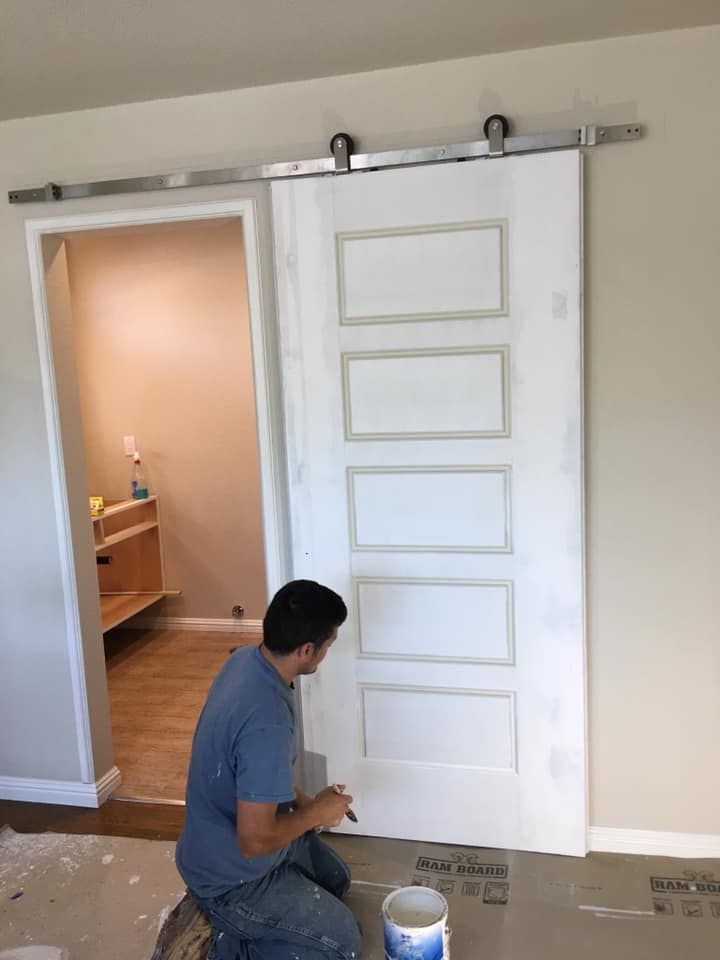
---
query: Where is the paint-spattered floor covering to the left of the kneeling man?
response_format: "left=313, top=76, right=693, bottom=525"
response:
left=0, top=827, right=185, bottom=960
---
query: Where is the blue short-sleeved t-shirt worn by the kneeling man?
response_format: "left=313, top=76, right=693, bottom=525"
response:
left=175, top=646, right=295, bottom=898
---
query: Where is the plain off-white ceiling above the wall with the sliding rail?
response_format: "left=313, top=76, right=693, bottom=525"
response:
left=0, top=0, right=720, bottom=119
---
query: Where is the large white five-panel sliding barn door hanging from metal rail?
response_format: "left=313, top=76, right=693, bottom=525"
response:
left=272, top=151, right=586, bottom=855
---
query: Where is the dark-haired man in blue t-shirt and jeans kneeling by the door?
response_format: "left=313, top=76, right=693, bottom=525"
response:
left=176, top=580, right=360, bottom=960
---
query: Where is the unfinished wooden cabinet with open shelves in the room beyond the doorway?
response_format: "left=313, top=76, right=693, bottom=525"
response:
left=93, top=497, right=179, bottom=633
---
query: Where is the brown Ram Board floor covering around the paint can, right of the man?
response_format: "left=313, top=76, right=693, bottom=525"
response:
left=332, top=836, right=720, bottom=960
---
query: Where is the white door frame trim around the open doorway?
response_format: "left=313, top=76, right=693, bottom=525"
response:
left=25, top=198, right=291, bottom=806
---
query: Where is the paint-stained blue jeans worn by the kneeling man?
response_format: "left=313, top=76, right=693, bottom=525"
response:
left=196, top=833, right=361, bottom=960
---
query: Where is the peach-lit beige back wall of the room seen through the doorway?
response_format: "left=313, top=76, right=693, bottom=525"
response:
left=67, top=220, right=266, bottom=619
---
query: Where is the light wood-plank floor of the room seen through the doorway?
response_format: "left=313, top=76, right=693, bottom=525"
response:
left=105, top=629, right=257, bottom=801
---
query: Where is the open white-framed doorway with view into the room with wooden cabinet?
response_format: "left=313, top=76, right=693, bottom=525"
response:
left=28, top=201, right=283, bottom=803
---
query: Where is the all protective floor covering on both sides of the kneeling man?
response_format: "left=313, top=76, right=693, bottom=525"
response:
left=0, top=830, right=720, bottom=960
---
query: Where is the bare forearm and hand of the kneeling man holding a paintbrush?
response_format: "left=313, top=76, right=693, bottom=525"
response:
left=237, top=787, right=352, bottom=860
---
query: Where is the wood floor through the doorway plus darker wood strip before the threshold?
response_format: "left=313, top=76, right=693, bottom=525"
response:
left=0, top=629, right=257, bottom=840
